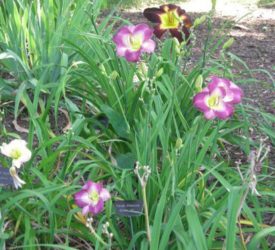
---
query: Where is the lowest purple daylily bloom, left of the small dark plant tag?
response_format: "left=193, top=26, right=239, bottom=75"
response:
left=74, top=181, right=111, bottom=215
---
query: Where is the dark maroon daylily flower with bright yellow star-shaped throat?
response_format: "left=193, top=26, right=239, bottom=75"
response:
left=143, top=4, right=192, bottom=42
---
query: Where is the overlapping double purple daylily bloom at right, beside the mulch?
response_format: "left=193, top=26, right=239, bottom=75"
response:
left=193, top=76, right=243, bottom=120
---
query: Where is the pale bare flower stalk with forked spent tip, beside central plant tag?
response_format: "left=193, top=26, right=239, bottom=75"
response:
left=134, top=162, right=151, bottom=243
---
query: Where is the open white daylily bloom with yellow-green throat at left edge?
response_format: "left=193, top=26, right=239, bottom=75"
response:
left=0, top=139, right=32, bottom=168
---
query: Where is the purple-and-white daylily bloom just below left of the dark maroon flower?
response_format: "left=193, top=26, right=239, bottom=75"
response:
left=113, top=24, right=156, bottom=62
